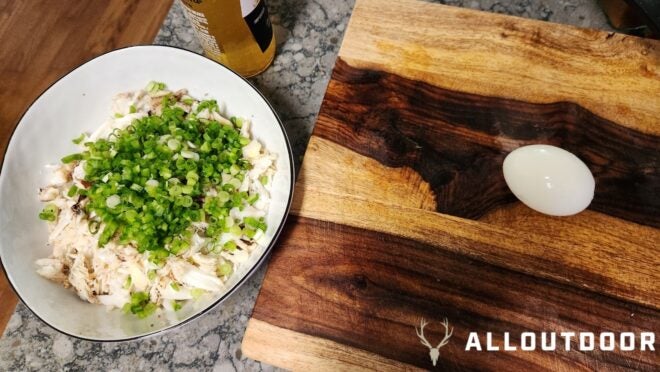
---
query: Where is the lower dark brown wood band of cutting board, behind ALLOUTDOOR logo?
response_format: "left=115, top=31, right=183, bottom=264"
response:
left=248, top=217, right=660, bottom=371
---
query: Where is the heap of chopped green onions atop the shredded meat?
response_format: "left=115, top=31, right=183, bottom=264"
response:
left=39, top=87, right=268, bottom=274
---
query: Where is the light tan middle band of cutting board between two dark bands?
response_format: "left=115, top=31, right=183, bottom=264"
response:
left=292, top=137, right=660, bottom=308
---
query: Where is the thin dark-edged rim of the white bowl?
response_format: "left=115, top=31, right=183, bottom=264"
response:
left=0, top=44, right=296, bottom=343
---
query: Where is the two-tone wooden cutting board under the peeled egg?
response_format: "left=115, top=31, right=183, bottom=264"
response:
left=243, top=0, right=660, bottom=371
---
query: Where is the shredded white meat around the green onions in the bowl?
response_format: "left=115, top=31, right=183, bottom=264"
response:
left=35, top=84, right=276, bottom=310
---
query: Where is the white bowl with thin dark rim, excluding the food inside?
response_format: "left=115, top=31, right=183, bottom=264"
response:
left=0, top=46, right=294, bottom=341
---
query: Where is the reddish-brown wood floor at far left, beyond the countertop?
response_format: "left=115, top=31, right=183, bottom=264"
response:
left=0, top=0, right=172, bottom=334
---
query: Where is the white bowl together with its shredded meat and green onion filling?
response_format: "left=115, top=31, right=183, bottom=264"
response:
left=0, top=45, right=295, bottom=341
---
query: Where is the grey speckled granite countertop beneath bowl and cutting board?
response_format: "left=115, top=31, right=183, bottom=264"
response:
left=0, top=0, right=611, bottom=371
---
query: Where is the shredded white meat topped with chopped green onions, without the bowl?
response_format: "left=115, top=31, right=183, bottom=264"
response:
left=36, top=82, right=277, bottom=318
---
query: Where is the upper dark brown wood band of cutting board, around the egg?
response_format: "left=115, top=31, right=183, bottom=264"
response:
left=314, top=58, right=660, bottom=227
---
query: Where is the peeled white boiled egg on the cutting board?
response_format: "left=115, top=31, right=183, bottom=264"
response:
left=502, top=145, right=596, bottom=216
